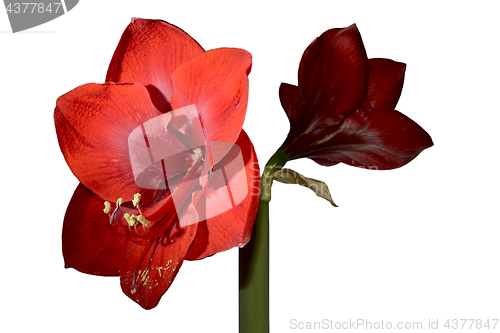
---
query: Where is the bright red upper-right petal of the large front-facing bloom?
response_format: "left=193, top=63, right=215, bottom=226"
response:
left=172, top=48, right=252, bottom=163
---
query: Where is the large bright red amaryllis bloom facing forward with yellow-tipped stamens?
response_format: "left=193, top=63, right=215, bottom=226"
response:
left=54, top=19, right=259, bottom=309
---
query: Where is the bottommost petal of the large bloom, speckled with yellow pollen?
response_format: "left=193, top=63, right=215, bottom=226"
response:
left=120, top=223, right=197, bottom=309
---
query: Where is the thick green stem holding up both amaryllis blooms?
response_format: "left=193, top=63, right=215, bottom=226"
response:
left=239, top=151, right=288, bottom=333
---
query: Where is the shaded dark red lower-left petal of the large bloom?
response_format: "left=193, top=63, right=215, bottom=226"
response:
left=62, top=184, right=126, bottom=276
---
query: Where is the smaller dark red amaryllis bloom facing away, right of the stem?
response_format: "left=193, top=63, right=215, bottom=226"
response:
left=280, top=25, right=433, bottom=169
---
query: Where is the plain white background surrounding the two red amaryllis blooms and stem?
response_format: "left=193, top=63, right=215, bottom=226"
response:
left=0, top=0, right=500, bottom=333
